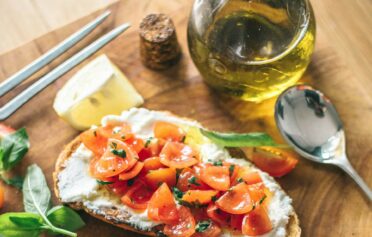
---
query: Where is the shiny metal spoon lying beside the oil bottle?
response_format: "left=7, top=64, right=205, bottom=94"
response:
left=275, top=85, right=372, bottom=201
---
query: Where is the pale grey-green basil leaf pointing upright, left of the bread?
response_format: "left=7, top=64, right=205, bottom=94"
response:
left=22, top=164, right=50, bottom=214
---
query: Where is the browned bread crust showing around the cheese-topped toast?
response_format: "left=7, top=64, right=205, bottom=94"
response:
left=53, top=116, right=301, bottom=237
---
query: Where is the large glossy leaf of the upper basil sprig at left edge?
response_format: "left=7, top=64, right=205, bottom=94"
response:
left=0, top=128, right=30, bottom=170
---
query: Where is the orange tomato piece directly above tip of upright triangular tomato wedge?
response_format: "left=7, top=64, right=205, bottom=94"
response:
left=144, top=168, right=176, bottom=189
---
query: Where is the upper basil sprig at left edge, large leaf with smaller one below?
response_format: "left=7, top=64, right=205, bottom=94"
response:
left=0, top=128, right=30, bottom=188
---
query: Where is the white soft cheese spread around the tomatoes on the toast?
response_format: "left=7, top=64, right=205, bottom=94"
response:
left=58, top=108, right=293, bottom=237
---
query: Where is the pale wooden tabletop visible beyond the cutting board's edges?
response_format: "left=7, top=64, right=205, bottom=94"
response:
left=0, top=0, right=372, bottom=94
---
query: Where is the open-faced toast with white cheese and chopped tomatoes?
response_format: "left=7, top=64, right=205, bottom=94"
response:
left=54, top=109, right=301, bottom=237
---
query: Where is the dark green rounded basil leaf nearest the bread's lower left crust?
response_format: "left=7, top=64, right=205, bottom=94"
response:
left=47, top=206, right=85, bottom=231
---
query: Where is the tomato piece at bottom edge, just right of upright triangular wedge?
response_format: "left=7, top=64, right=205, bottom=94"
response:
left=163, top=206, right=195, bottom=237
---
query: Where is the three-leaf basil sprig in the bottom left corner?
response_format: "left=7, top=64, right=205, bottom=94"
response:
left=0, top=165, right=85, bottom=237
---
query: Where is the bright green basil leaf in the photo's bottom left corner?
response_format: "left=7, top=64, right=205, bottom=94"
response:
left=0, top=212, right=43, bottom=237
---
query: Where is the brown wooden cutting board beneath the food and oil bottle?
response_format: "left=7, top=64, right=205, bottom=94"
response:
left=0, top=0, right=372, bottom=236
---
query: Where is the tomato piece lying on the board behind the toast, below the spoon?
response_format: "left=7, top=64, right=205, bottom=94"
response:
left=252, top=147, right=298, bottom=177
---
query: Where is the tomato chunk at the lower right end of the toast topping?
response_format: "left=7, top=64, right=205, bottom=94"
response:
left=242, top=206, right=273, bottom=236
